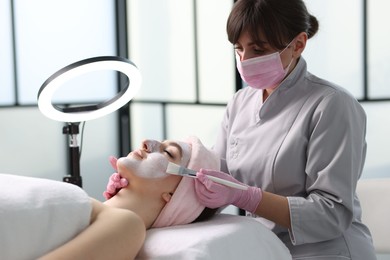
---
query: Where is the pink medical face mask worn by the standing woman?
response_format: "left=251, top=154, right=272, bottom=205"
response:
left=236, top=41, right=292, bottom=89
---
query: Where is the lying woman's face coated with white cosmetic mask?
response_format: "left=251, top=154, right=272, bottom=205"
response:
left=117, top=140, right=191, bottom=184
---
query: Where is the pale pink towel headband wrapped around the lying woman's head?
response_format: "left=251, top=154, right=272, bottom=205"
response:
left=152, top=136, right=220, bottom=228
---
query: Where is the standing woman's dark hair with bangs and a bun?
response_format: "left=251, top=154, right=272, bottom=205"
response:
left=226, top=0, right=318, bottom=49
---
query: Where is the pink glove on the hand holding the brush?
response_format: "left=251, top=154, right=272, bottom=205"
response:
left=195, top=169, right=263, bottom=213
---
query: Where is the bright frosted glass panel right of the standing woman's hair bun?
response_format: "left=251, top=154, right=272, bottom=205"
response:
left=303, top=0, right=364, bottom=98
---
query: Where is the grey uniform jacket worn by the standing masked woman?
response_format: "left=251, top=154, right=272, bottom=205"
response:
left=214, top=57, right=375, bottom=260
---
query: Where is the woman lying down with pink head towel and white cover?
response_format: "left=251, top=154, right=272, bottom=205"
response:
left=0, top=137, right=219, bottom=259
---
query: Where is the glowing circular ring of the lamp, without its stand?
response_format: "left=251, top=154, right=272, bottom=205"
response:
left=38, top=56, right=141, bottom=123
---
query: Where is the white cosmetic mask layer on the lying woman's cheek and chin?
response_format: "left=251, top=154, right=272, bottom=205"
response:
left=117, top=153, right=168, bottom=179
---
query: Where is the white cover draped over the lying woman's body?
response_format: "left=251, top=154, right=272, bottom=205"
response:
left=0, top=174, right=92, bottom=260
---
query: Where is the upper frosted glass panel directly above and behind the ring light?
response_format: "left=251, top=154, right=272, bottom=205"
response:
left=14, top=0, right=116, bottom=104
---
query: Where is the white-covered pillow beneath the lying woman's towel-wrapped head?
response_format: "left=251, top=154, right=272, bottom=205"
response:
left=136, top=214, right=291, bottom=260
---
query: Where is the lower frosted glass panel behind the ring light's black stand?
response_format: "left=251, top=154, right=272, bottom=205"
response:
left=0, top=107, right=118, bottom=201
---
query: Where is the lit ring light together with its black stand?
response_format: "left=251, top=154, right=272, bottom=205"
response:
left=38, top=56, right=141, bottom=187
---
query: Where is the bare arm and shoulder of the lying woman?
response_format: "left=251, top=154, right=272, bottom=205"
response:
left=40, top=199, right=146, bottom=260
